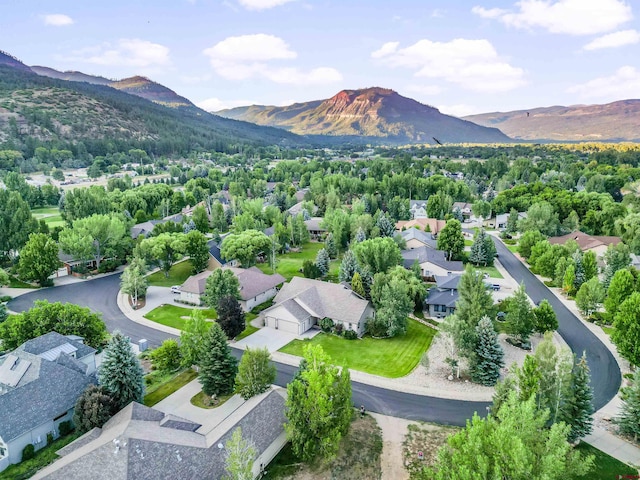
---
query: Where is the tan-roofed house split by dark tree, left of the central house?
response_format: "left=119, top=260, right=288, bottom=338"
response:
left=180, top=266, right=285, bottom=312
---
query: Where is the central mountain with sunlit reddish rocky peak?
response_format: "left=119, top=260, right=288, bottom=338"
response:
left=215, top=87, right=510, bottom=143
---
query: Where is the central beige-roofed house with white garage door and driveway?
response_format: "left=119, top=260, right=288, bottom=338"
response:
left=262, top=277, right=375, bottom=335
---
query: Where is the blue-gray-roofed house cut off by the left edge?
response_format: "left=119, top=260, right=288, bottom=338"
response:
left=0, top=332, right=96, bottom=471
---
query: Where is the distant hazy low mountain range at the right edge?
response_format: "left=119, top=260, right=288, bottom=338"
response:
left=464, top=100, right=640, bottom=142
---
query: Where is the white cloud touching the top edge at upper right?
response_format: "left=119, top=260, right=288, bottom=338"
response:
left=471, top=0, right=633, bottom=35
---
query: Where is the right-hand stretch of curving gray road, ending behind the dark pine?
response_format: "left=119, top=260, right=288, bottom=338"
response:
left=494, top=239, right=622, bottom=410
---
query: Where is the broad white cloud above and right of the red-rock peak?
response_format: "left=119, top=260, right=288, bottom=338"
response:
left=371, top=38, right=525, bottom=93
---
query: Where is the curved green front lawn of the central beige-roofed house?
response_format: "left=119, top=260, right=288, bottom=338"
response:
left=280, top=319, right=436, bottom=378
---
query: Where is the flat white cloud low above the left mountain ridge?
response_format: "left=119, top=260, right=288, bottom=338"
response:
left=67, top=38, right=170, bottom=68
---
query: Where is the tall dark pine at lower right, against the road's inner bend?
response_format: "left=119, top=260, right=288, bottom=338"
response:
left=559, top=352, right=593, bottom=443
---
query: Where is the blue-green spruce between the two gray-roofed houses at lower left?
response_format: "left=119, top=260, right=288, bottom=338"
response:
left=98, top=330, right=144, bottom=411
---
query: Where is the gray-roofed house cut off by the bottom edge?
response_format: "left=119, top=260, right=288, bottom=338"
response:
left=32, top=387, right=286, bottom=480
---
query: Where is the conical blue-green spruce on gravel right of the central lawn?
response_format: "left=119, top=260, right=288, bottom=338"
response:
left=471, top=316, right=504, bottom=387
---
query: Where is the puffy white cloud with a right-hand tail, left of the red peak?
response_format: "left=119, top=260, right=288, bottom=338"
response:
left=203, top=33, right=342, bottom=85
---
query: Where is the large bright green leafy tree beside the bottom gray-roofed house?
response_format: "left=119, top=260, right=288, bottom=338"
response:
left=285, top=345, right=352, bottom=461
